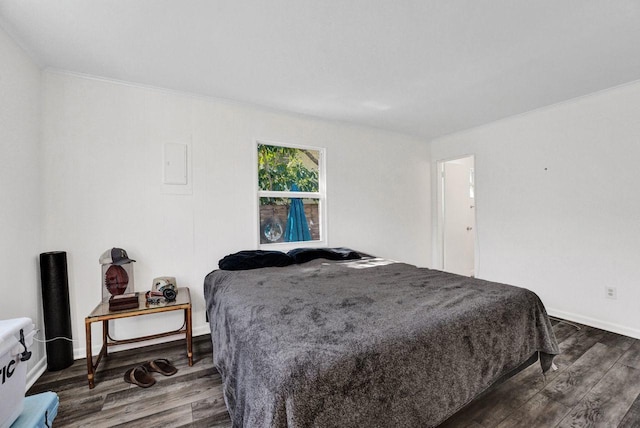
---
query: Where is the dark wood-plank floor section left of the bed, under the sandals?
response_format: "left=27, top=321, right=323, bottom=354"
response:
left=27, top=335, right=231, bottom=428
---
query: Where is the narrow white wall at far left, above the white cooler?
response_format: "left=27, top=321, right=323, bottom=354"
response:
left=0, top=29, right=44, bottom=378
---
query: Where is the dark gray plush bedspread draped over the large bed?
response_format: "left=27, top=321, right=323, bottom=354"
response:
left=204, top=259, right=559, bottom=427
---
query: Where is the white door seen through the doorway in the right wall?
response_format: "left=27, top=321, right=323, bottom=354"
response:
left=442, top=157, right=475, bottom=276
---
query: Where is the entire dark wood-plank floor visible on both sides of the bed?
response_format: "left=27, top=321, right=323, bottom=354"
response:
left=28, top=323, right=640, bottom=428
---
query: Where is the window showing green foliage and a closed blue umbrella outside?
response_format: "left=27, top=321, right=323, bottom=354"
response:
left=257, top=141, right=326, bottom=247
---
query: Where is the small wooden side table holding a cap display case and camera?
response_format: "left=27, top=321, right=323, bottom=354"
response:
left=84, top=287, right=193, bottom=388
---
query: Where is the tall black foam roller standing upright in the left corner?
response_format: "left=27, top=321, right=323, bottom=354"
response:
left=40, top=251, right=73, bottom=371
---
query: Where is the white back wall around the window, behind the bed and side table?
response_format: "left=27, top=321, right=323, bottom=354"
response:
left=43, top=72, right=431, bottom=356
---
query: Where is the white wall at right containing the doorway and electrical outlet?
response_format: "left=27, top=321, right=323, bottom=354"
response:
left=431, top=83, right=640, bottom=338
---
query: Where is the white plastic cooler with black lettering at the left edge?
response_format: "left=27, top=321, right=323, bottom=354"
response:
left=0, top=318, right=35, bottom=428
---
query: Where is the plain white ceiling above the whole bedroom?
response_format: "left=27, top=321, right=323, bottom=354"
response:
left=0, top=0, right=640, bottom=139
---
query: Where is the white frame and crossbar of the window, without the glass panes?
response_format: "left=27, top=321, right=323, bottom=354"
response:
left=253, top=139, right=328, bottom=251
